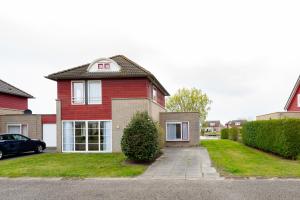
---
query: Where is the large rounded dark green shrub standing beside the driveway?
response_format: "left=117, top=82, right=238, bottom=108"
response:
left=121, top=112, right=160, bottom=161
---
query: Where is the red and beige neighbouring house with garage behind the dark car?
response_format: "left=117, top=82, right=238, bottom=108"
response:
left=0, top=80, right=56, bottom=147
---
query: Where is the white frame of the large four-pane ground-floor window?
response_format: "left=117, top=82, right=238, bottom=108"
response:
left=61, top=120, right=112, bottom=153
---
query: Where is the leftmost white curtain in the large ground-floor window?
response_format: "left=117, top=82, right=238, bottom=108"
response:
left=63, top=122, right=74, bottom=151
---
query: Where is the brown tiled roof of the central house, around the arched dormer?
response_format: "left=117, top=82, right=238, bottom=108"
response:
left=46, top=55, right=170, bottom=96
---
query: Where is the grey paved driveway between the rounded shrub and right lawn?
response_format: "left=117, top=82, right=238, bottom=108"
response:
left=139, top=147, right=221, bottom=179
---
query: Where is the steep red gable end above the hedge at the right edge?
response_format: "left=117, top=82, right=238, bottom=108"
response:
left=284, top=76, right=300, bottom=112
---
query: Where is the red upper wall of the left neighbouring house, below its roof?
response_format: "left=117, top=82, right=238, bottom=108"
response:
left=0, top=93, right=28, bottom=110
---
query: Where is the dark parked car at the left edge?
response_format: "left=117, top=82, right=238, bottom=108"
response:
left=0, top=134, right=46, bottom=159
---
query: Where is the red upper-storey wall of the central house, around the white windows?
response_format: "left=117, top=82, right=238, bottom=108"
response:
left=57, top=78, right=161, bottom=120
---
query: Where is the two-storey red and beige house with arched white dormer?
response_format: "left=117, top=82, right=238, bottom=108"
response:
left=46, top=55, right=199, bottom=152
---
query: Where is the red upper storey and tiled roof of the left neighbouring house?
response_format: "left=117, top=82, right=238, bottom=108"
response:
left=0, top=80, right=33, bottom=115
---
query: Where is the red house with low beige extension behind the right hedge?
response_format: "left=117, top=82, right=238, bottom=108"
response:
left=256, top=76, right=300, bottom=120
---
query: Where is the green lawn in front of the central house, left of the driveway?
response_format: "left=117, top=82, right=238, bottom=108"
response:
left=0, top=153, right=147, bottom=177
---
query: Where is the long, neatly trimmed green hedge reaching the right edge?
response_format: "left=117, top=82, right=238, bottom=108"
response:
left=242, top=119, right=300, bottom=159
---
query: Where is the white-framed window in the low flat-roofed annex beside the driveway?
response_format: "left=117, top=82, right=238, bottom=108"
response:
left=166, top=122, right=189, bottom=141
